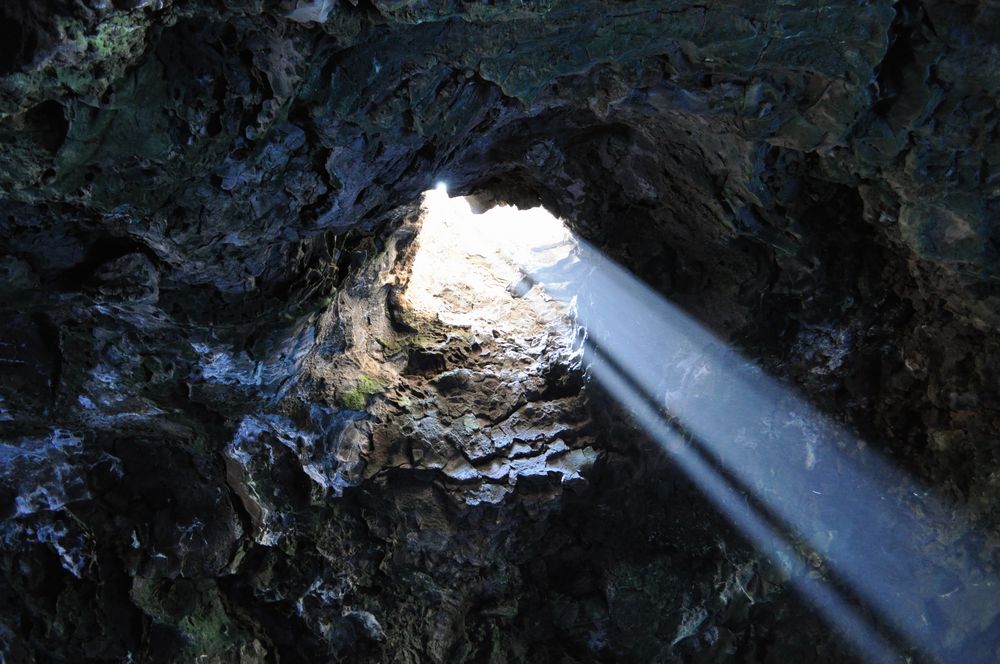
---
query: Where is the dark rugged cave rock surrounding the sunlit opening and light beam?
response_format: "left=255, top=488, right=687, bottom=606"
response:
left=0, top=0, right=1000, bottom=661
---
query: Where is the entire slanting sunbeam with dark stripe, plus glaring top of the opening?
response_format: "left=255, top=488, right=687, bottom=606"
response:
left=416, top=189, right=1000, bottom=664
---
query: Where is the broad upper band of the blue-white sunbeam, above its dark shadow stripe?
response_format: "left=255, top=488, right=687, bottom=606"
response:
left=531, top=241, right=1000, bottom=664
